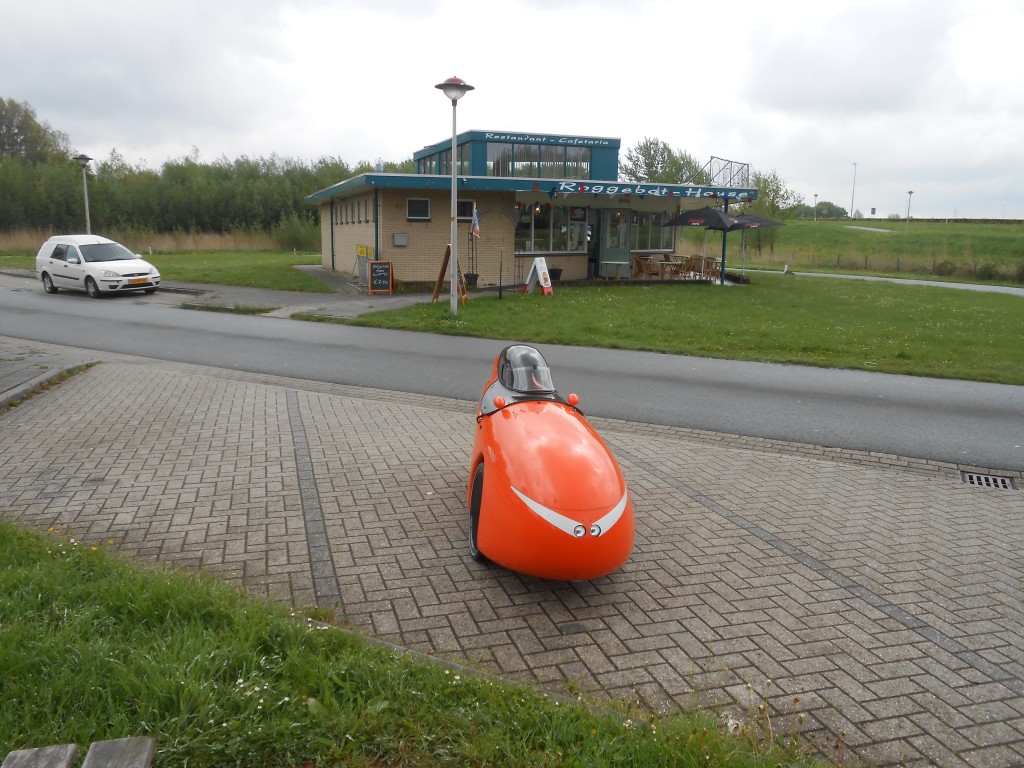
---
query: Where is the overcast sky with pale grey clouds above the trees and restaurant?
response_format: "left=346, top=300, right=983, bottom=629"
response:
left=0, top=0, right=1024, bottom=219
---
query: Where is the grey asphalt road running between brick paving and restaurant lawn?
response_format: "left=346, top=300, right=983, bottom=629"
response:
left=6, top=278, right=1024, bottom=470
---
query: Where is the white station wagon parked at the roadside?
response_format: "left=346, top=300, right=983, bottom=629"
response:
left=36, top=234, right=160, bottom=298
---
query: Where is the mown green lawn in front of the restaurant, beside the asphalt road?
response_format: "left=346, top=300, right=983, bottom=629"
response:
left=319, top=274, right=1024, bottom=384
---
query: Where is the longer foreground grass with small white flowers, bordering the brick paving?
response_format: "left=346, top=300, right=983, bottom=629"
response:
left=0, top=524, right=818, bottom=768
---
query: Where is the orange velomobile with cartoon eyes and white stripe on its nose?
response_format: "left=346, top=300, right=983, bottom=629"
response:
left=468, top=344, right=633, bottom=581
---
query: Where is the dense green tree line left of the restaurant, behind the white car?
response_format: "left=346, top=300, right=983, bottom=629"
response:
left=0, top=98, right=413, bottom=243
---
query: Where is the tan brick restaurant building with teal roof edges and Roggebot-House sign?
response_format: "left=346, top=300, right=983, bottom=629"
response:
left=306, top=130, right=758, bottom=287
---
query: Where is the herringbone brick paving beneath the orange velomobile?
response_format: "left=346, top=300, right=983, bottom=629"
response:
left=0, top=355, right=1024, bottom=768
